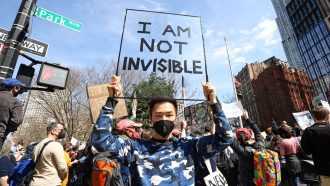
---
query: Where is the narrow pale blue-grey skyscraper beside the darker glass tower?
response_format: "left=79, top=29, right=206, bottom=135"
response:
left=272, top=0, right=305, bottom=70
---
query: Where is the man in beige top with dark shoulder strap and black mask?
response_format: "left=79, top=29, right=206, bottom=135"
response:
left=30, top=123, right=68, bottom=186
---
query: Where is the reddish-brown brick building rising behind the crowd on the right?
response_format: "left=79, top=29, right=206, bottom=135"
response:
left=252, top=61, right=314, bottom=129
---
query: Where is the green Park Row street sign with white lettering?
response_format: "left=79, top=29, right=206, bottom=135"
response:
left=34, top=7, right=81, bottom=32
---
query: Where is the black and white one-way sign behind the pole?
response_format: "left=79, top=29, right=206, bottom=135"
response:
left=0, top=28, right=48, bottom=57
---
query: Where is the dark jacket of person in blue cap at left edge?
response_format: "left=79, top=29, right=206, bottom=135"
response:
left=0, top=91, right=23, bottom=138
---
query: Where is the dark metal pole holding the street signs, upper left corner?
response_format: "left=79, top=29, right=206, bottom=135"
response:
left=0, top=0, right=37, bottom=79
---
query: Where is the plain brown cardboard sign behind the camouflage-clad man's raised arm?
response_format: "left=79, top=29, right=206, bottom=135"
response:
left=87, top=84, right=127, bottom=123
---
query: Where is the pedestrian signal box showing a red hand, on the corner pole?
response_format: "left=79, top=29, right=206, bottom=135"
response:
left=37, top=63, right=70, bottom=89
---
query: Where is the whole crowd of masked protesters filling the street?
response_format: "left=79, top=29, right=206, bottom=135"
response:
left=0, top=76, right=330, bottom=186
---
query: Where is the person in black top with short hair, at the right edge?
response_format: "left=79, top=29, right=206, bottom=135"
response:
left=301, top=106, right=330, bottom=186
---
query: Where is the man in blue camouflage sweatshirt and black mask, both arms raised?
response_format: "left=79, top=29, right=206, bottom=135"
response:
left=92, top=76, right=232, bottom=185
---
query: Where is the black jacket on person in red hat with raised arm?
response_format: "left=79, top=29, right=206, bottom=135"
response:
left=231, top=119, right=265, bottom=186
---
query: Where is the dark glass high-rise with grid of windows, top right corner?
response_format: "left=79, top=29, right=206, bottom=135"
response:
left=285, top=0, right=330, bottom=99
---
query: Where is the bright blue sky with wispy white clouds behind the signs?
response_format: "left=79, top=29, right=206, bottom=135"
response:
left=0, top=0, right=286, bottom=100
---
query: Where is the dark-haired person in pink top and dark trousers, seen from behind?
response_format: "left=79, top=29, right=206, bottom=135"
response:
left=278, top=125, right=301, bottom=186
